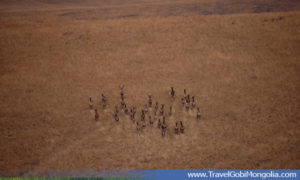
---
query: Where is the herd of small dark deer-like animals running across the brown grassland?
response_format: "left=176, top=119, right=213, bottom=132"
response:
left=89, top=85, right=201, bottom=137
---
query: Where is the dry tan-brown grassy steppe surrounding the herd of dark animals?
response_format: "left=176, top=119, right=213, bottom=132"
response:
left=0, top=1, right=300, bottom=173
